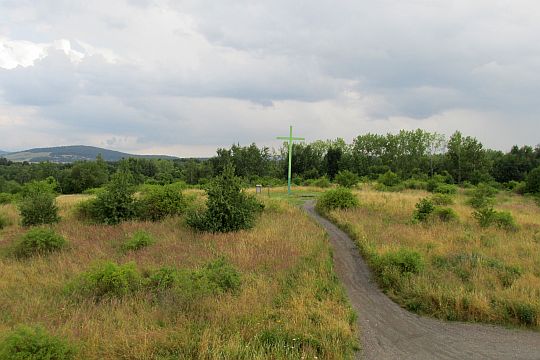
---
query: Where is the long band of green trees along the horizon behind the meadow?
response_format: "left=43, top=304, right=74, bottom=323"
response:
left=0, top=129, right=540, bottom=194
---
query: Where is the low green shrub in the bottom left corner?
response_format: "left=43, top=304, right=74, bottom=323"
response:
left=0, top=325, right=76, bottom=360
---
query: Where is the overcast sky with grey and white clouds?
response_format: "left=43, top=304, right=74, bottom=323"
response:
left=0, top=0, right=540, bottom=156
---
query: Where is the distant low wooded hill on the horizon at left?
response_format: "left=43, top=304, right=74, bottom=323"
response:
left=1, top=145, right=176, bottom=163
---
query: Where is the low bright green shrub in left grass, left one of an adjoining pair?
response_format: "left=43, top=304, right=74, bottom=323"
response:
left=66, top=261, right=141, bottom=301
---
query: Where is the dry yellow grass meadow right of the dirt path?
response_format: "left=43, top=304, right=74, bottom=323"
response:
left=327, top=185, right=540, bottom=329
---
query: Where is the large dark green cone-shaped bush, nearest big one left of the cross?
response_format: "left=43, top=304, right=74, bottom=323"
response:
left=187, top=164, right=264, bottom=233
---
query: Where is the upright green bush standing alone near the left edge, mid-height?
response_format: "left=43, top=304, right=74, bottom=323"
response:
left=19, top=181, right=60, bottom=226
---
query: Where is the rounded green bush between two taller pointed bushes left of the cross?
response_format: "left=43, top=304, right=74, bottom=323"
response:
left=136, top=185, right=186, bottom=221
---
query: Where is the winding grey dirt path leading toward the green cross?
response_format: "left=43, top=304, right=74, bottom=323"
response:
left=304, top=201, right=540, bottom=360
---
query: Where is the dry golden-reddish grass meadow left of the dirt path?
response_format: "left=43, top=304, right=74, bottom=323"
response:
left=0, top=191, right=358, bottom=359
